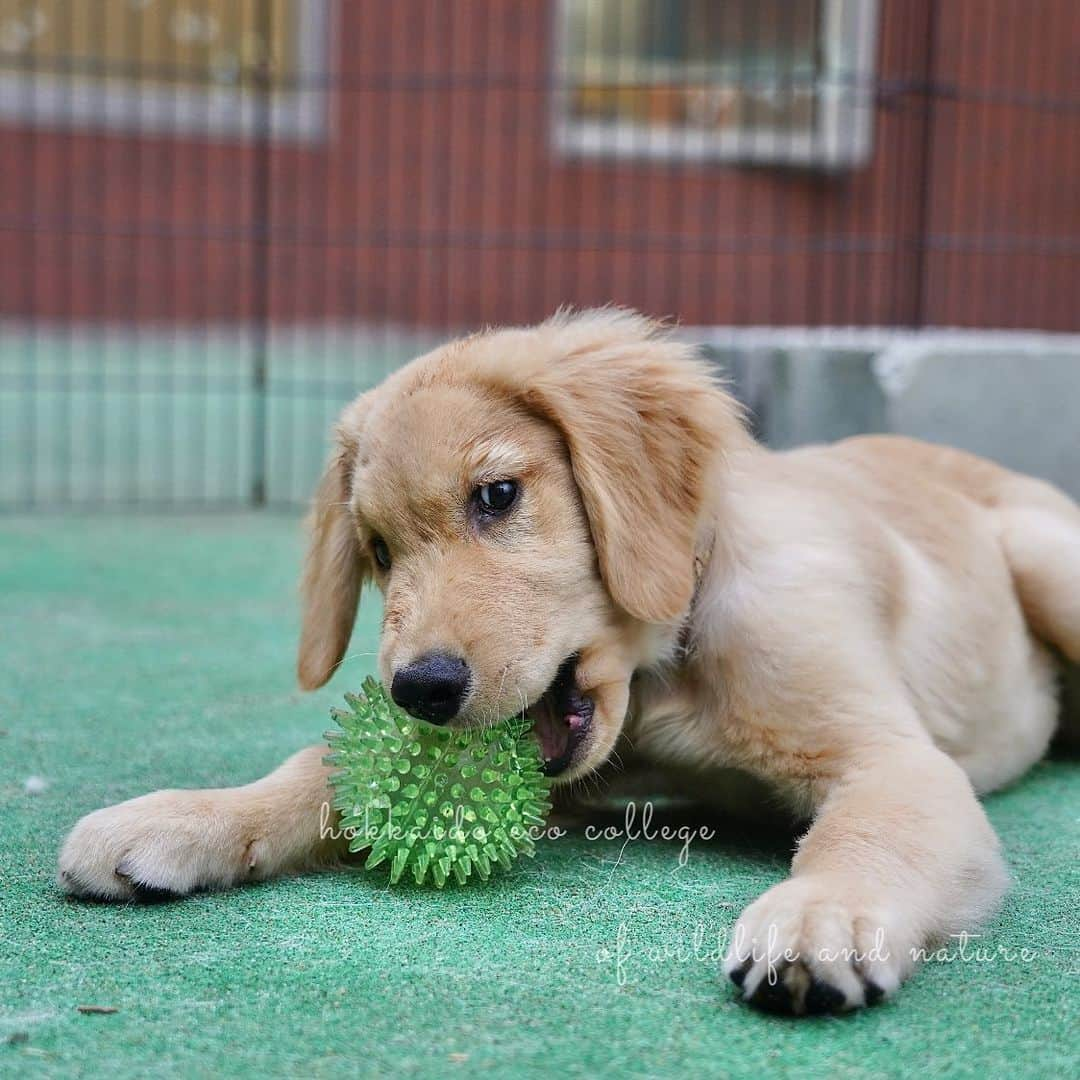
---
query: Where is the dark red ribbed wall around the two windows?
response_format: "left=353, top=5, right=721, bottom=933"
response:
left=0, top=0, right=1080, bottom=329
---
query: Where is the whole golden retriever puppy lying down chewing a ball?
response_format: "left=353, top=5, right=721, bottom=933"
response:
left=59, top=310, right=1080, bottom=1013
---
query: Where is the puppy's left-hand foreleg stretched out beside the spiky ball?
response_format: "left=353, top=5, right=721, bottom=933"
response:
left=58, top=746, right=347, bottom=900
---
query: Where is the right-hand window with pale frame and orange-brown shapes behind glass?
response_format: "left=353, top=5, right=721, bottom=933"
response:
left=554, top=0, right=878, bottom=167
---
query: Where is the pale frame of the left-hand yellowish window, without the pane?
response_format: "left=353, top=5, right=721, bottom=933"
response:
left=0, top=0, right=334, bottom=143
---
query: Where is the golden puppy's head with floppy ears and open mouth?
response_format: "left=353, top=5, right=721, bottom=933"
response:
left=299, top=310, right=745, bottom=779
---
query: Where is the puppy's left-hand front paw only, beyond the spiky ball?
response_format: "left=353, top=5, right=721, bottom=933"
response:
left=57, top=791, right=257, bottom=901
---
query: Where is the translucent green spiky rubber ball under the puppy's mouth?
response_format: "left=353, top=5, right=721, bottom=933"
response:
left=326, top=678, right=551, bottom=889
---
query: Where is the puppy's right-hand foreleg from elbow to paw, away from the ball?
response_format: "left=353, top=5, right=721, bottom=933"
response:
left=725, top=735, right=1007, bottom=1013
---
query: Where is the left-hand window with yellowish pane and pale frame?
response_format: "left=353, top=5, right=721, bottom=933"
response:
left=0, top=0, right=328, bottom=138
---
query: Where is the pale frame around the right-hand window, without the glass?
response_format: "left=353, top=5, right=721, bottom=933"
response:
left=551, top=0, right=880, bottom=170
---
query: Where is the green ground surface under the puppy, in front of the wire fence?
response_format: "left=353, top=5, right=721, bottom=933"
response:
left=0, top=515, right=1080, bottom=1080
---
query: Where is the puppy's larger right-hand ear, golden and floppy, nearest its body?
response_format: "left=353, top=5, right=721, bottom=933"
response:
left=490, top=309, right=748, bottom=623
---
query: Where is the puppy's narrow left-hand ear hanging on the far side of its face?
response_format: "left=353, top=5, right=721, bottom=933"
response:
left=297, top=394, right=372, bottom=690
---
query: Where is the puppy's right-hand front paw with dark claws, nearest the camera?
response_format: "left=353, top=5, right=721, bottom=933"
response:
left=724, top=876, right=916, bottom=1015
